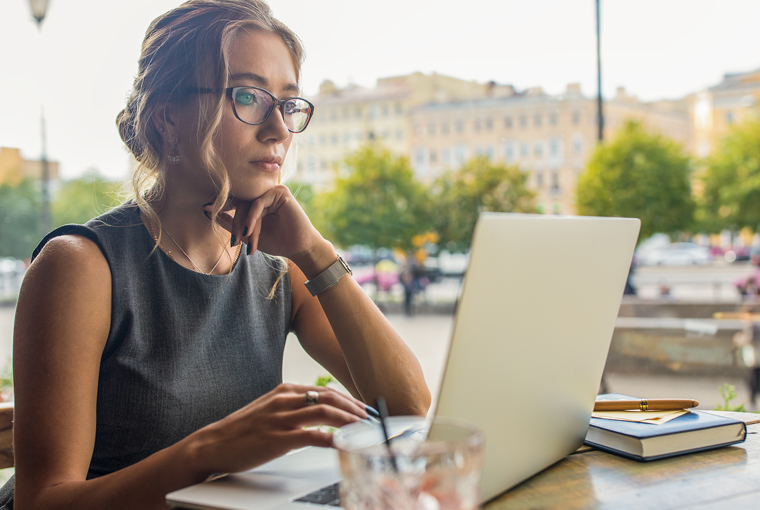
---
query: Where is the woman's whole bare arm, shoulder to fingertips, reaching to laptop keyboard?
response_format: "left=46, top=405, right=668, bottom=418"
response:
left=14, top=236, right=366, bottom=510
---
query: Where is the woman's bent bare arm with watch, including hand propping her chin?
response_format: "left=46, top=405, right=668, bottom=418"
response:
left=220, top=185, right=430, bottom=415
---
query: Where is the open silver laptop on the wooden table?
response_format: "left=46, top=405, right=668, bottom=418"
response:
left=166, top=213, right=640, bottom=510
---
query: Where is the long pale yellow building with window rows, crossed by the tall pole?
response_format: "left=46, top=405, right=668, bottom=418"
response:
left=410, top=84, right=691, bottom=214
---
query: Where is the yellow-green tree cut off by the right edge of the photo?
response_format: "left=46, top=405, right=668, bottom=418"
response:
left=698, top=116, right=760, bottom=232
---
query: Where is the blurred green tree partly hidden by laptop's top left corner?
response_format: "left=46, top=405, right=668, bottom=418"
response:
left=433, top=157, right=536, bottom=252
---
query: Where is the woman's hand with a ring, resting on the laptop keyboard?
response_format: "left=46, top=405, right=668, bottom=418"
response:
left=189, top=384, right=367, bottom=475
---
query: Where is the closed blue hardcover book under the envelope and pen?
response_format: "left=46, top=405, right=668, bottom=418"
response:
left=585, top=394, right=747, bottom=462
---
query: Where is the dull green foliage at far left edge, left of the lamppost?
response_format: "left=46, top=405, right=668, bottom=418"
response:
left=0, top=179, right=41, bottom=259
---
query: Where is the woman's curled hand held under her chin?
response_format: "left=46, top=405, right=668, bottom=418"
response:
left=207, top=184, right=326, bottom=264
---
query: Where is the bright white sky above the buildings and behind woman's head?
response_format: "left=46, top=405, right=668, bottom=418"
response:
left=0, top=0, right=760, bottom=179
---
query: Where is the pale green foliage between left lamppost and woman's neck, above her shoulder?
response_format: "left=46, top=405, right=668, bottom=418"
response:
left=51, top=172, right=120, bottom=228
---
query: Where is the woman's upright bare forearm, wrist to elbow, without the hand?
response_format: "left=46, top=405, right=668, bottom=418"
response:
left=291, top=255, right=430, bottom=416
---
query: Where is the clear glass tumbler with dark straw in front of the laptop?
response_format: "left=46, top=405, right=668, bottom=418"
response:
left=333, top=416, right=483, bottom=510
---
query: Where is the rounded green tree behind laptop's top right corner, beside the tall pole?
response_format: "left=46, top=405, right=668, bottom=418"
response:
left=576, top=121, right=695, bottom=239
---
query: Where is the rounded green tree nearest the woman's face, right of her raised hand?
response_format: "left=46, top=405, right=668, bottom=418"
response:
left=312, top=145, right=430, bottom=252
